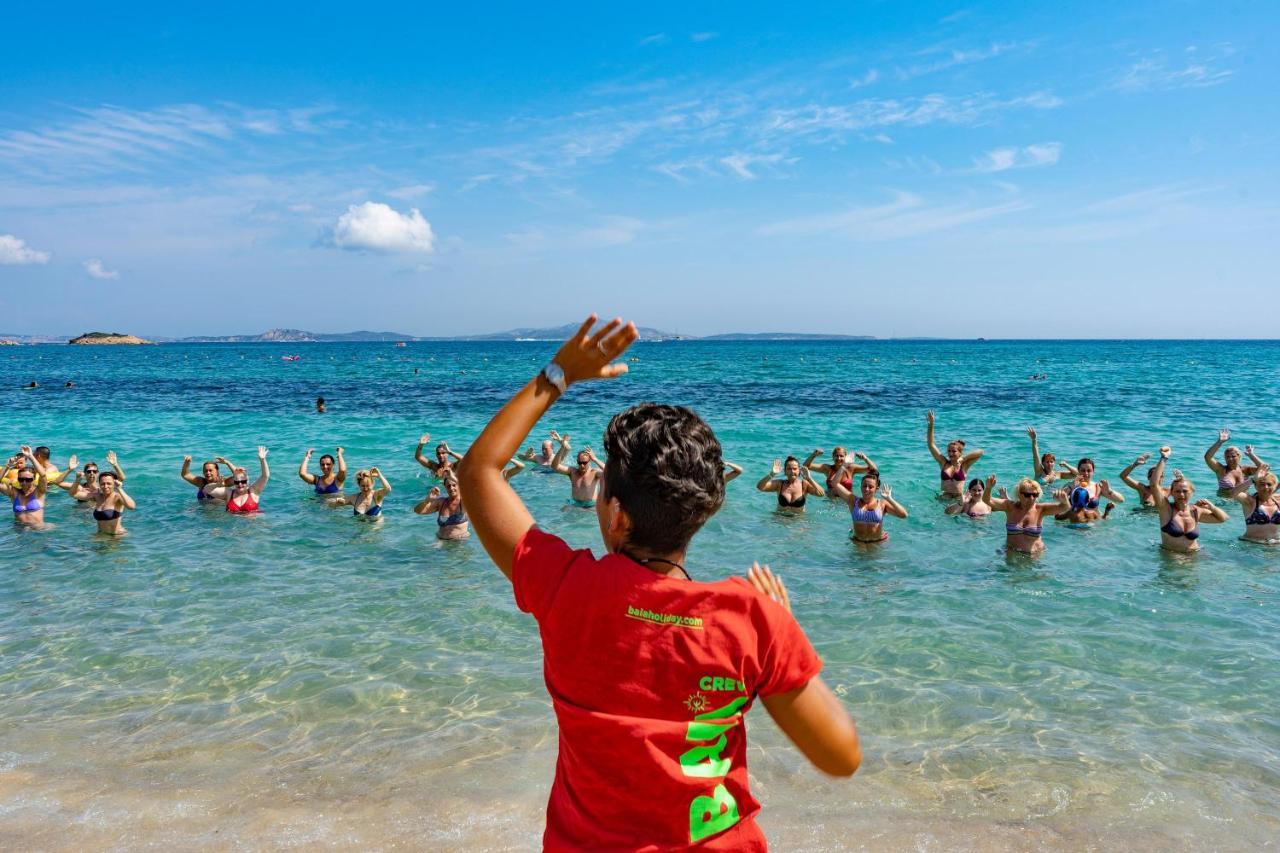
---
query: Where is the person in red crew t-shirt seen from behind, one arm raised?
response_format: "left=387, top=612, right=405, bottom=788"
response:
left=458, top=315, right=861, bottom=850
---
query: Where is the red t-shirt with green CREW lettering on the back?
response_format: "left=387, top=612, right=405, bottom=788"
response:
left=512, top=528, right=822, bottom=850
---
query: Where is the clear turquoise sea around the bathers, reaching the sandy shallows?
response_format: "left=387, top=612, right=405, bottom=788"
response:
left=0, top=342, right=1280, bottom=849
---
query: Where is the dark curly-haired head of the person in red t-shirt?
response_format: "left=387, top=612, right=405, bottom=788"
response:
left=603, top=402, right=724, bottom=553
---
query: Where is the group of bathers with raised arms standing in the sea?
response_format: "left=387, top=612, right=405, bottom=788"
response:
left=0, top=411, right=1280, bottom=556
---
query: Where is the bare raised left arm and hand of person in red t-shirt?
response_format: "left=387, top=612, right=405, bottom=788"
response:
left=458, top=314, right=639, bottom=580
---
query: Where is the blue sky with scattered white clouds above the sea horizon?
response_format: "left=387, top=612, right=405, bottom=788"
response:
left=0, top=1, right=1280, bottom=337
